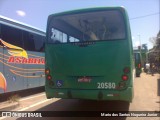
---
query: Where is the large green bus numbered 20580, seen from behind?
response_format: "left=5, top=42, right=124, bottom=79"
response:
left=45, top=7, right=134, bottom=102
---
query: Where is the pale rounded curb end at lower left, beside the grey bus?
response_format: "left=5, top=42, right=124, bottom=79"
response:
left=0, top=102, right=19, bottom=111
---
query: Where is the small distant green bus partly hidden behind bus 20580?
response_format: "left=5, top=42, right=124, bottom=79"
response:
left=134, top=51, right=142, bottom=77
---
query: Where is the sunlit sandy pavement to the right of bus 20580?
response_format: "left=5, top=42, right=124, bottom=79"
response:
left=129, top=73, right=160, bottom=111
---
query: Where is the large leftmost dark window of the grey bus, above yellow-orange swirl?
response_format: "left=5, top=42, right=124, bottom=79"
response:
left=1, top=25, right=23, bottom=48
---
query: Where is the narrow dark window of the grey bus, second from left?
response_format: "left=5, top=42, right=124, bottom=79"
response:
left=23, top=31, right=35, bottom=51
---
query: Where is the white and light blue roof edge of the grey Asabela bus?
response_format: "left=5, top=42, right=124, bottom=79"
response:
left=0, top=15, right=45, bottom=36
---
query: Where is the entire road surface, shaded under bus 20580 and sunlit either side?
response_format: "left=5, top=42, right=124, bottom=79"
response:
left=0, top=73, right=160, bottom=120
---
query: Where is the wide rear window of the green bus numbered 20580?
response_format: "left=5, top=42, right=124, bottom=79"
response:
left=48, top=10, right=126, bottom=43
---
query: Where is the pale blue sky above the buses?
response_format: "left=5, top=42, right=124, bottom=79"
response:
left=0, top=0, right=160, bottom=49
